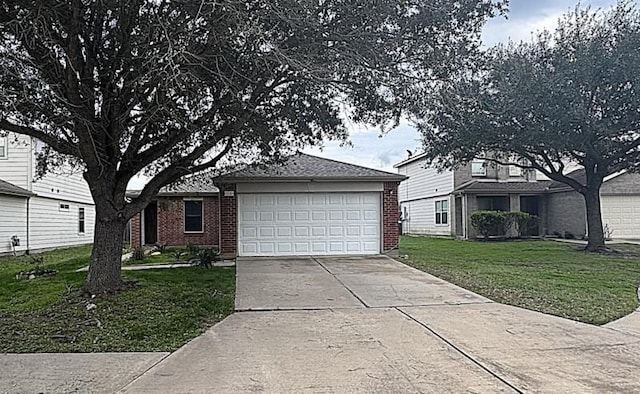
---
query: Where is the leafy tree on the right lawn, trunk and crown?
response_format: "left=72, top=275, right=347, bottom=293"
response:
left=416, top=1, right=640, bottom=251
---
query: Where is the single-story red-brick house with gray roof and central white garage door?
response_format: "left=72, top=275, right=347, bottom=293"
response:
left=132, top=153, right=405, bottom=256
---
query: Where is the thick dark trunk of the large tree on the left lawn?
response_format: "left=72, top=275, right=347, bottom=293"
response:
left=85, top=214, right=127, bottom=294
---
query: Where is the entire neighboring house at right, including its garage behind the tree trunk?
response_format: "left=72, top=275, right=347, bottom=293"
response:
left=394, top=154, right=640, bottom=238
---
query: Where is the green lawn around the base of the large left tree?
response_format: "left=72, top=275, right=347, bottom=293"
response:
left=0, top=247, right=235, bottom=353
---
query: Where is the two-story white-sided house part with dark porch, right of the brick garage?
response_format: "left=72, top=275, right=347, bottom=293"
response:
left=394, top=154, right=550, bottom=238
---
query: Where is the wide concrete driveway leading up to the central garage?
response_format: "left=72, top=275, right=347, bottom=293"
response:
left=123, top=256, right=640, bottom=393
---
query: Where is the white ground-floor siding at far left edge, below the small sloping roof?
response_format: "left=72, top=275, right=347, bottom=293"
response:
left=0, top=195, right=27, bottom=254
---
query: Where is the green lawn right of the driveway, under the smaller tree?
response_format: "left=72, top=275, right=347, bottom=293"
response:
left=400, top=237, right=640, bottom=324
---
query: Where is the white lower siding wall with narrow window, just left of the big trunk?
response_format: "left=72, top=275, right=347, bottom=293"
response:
left=29, top=197, right=95, bottom=249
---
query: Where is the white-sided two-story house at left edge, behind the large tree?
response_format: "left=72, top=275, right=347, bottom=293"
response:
left=0, top=134, right=95, bottom=254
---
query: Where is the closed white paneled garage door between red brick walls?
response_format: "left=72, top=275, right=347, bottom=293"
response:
left=238, top=193, right=381, bottom=256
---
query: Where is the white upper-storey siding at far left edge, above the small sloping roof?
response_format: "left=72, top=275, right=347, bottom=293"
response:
left=0, top=133, right=31, bottom=190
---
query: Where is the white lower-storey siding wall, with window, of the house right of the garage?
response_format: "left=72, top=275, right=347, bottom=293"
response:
left=400, top=195, right=454, bottom=235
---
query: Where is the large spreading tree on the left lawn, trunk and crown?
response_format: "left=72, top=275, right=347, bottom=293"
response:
left=0, top=0, right=502, bottom=293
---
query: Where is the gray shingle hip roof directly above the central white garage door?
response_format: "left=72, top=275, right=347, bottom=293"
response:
left=219, top=153, right=406, bottom=182
